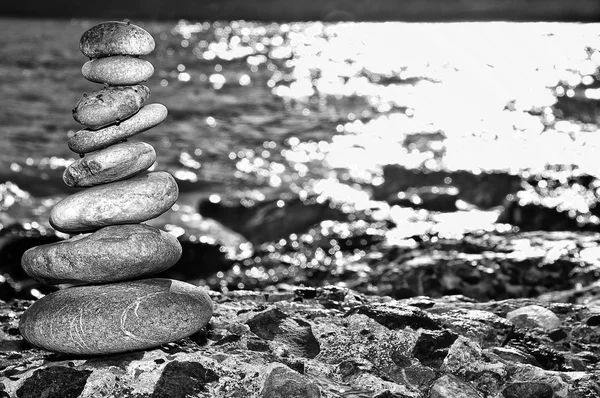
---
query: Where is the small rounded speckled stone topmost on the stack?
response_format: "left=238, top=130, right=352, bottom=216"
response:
left=79, top=21, right=155, bottom=58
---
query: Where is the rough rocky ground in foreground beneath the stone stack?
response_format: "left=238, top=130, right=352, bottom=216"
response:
left=0, top=287, right=600, bottom=398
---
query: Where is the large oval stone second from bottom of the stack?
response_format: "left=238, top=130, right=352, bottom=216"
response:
left=21, top=224, right=181, bottom=285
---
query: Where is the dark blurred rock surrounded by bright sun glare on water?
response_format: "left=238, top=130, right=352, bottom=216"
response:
left=373, top=165, right=521, bottom=209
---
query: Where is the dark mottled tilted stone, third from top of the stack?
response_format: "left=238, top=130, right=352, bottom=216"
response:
left=73, top=84, right=150, bottom=130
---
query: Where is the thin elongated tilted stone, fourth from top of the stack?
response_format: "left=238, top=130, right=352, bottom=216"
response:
left=68, top=104, right=168, bottom=153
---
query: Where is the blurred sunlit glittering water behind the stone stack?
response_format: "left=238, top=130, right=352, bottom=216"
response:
left=0, top=19, right=600, bottom=264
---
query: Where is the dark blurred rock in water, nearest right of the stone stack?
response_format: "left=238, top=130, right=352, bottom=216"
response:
left=199, top=194, right=349, bottom=244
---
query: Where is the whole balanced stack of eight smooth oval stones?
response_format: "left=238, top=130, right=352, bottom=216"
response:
left=19, top=22, right=213, bottom=355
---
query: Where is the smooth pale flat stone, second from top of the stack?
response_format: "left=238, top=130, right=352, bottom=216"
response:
left=81, top=55, right=154, bottom=86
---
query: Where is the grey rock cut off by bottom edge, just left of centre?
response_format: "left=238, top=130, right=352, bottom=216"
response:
left=261, top=367, right=321, bottom=398
